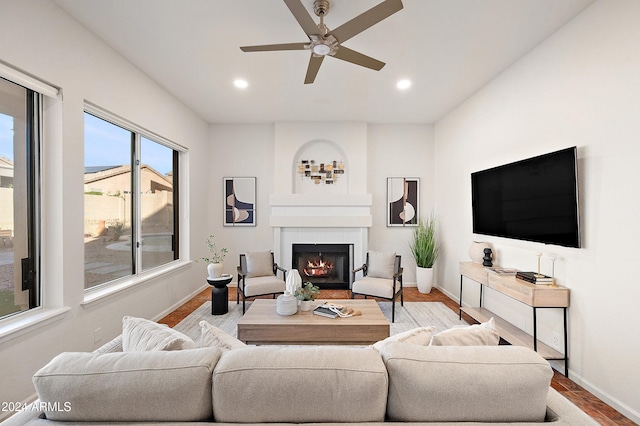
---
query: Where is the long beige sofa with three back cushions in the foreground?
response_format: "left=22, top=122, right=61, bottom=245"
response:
left=3, top=338, right=597, bottom=426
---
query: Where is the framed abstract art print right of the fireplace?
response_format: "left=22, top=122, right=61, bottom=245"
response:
left=387, top=178, right=420, bottom=226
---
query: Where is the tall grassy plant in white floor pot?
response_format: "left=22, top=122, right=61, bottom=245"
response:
left=409, top=213, right=440, bottom=293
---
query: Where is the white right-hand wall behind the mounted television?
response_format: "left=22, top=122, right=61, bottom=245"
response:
left=435, top=0, right=640, bottom=422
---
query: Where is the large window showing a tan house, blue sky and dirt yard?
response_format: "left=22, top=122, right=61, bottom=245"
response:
left=84, top=111, right=179, bottom=289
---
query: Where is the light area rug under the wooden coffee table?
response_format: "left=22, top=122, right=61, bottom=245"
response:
left=174, top=301, right=467, bottom=341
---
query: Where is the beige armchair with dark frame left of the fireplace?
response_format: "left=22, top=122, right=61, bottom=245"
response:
left=236, top=251, right=287, bottom=314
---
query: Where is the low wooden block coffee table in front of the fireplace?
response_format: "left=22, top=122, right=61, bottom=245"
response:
left=238, top=299, right=389, bottom=345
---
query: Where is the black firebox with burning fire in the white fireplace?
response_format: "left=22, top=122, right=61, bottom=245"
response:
left=291, top=244, right=353, bottom=289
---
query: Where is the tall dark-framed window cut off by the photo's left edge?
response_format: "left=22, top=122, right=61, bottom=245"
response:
left=0, top=78, right=41, bottom=318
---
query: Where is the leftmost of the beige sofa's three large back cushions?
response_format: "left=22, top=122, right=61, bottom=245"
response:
left=33, top=348, right=221, bottom=422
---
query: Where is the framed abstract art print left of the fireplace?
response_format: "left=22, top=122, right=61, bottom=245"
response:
left=224, top=177, right=256, bottom=226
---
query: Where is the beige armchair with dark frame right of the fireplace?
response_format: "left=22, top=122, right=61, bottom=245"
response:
left=351, top=251, right=404, bottom=322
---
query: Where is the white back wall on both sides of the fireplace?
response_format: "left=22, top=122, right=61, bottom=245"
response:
left=209, top=123, right=434, bottom=286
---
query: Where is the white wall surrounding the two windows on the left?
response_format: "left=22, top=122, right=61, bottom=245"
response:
left=0, top=0, right=209, bottom=418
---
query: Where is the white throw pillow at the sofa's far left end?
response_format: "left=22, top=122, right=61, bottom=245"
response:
left=122, top=316, right=196, bottom=352
